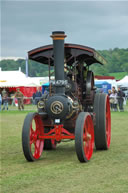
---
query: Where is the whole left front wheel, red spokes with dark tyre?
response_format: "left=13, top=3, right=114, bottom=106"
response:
left=22, top=113, right=44, bottom=161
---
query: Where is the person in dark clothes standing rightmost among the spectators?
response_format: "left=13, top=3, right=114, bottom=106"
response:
left=117, top=87, right=125, bottom=111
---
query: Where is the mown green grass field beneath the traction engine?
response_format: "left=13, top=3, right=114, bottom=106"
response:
left=0, top=110, right=128, bottom=193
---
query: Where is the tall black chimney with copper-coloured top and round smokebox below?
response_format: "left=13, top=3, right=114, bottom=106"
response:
left=46, top=31, right=71, bottom=120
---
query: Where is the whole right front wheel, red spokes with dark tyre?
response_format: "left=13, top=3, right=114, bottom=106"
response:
left=75, top=112, right=94, bottom=162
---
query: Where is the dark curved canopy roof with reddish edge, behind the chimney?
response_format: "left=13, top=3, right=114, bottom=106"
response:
left=28, top=44, right=106, bottom=66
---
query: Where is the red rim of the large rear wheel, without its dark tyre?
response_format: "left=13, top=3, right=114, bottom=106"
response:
left=106, top=97, right=111, bottom=148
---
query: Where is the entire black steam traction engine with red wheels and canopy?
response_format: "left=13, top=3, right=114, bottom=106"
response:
left=22, top=31, right=111, bottom=162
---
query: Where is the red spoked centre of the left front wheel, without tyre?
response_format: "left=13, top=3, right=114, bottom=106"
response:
left=30, top=115, right=44, bottom=159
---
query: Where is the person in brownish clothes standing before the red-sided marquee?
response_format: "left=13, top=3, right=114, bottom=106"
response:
left=15, top=88, right=24, bottom=110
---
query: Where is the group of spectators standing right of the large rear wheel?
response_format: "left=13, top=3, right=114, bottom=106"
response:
left=108, top=86, right=125, bottom=111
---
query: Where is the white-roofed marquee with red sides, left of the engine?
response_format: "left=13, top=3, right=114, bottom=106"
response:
left=0, top=71, right=40, bottom=104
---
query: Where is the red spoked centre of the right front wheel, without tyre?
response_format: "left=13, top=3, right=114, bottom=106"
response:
left=83, top=116, right=94, bottom=160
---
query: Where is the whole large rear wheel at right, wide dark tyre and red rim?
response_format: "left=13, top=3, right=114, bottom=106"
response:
left=94, top=93, right=111, bottom=150
